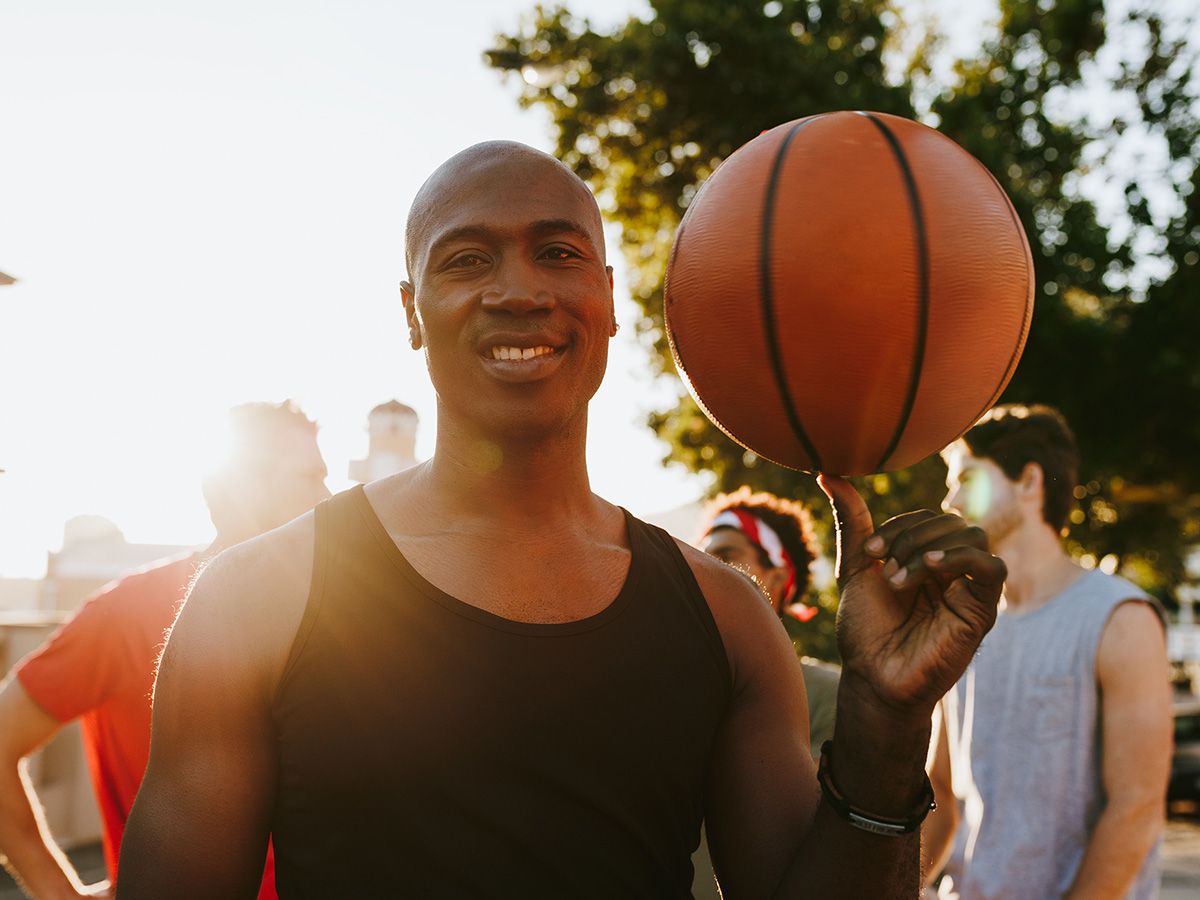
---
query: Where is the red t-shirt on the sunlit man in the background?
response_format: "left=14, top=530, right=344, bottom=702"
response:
left=16, top=556, right=275, bottom=900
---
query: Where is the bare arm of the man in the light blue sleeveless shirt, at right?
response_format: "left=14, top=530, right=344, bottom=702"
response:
left=1068, top=602, right=1171, bottom=900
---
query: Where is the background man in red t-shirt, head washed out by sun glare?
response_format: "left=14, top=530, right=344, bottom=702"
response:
left=0, top=402, right=329, bottom=899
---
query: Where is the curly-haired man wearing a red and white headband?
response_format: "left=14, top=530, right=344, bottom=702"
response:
left=701, top=487, right=838, bottom=758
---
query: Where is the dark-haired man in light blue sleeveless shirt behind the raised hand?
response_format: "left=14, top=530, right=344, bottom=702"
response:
left=925, top=406, right=1171, bottom=900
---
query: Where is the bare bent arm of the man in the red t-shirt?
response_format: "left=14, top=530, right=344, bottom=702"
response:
left=0, top=677, right=108, bottom=900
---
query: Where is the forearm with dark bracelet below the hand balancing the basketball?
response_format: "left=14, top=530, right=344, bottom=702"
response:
left=776, top=679, right=930, bottom=900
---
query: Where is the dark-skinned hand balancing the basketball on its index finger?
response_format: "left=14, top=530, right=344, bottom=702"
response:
left=817, top=475, right=1007, bottom=716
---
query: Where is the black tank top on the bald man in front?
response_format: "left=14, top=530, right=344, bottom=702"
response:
left=271, top=487, right=731, bottom=900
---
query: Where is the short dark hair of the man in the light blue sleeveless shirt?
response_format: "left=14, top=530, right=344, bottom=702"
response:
left=961, top=403, right=1079, bottom=532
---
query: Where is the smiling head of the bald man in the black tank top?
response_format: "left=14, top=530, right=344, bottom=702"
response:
left=401, top=144, right=613, bottom=446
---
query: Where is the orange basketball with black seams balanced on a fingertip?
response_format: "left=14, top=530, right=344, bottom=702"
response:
left=664, top=112, right=1033, bottom=475
